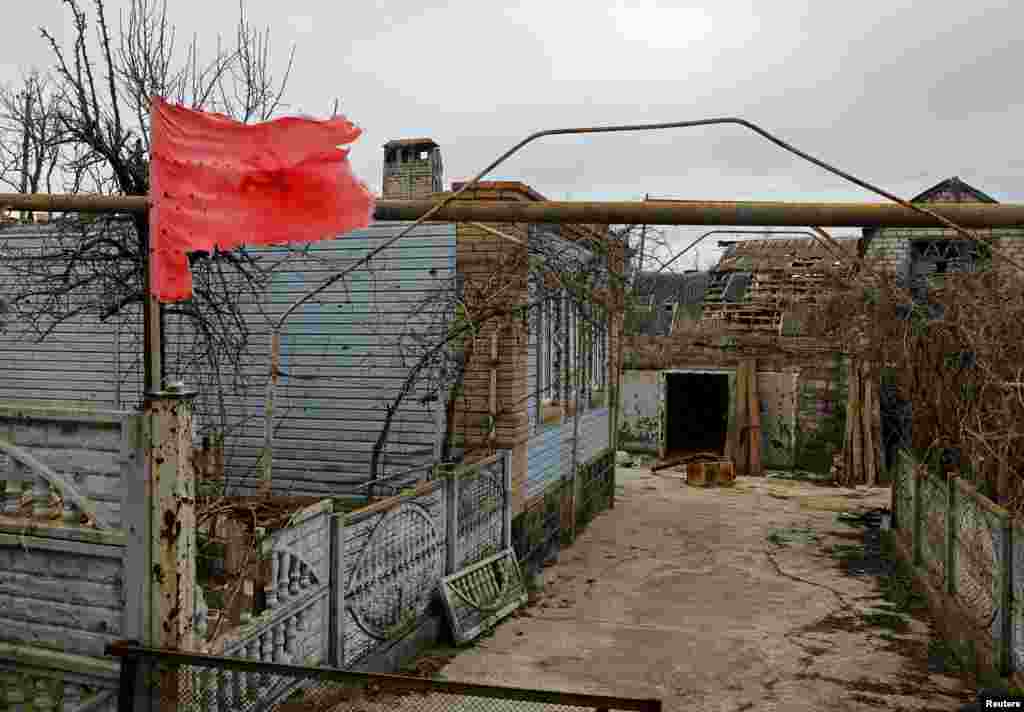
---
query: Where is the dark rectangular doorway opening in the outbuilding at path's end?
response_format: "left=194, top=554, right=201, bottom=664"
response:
left=665, top=373, right=729, bottom=455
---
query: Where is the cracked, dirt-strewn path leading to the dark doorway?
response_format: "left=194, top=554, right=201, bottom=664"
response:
left=421, top=469, right=973, bottom=712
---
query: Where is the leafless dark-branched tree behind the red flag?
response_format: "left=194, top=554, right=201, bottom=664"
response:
left=0, top=0, right=294, bottom=432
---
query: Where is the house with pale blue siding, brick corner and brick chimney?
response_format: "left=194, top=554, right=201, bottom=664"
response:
left=0, top=138, right=613, bottom=524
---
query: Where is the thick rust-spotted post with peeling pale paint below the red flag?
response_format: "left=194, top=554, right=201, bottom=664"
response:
left=142, top=389, right=196, bottom=707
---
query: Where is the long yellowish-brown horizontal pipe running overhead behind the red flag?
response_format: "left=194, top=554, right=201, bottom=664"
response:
left=6, top=194, right=1024, bottom=227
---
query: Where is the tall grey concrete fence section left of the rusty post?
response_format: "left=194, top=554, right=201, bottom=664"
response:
left=0, top=407, right=142, bottom=712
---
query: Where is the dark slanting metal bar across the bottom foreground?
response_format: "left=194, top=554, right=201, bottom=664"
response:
left=106, top=645, right=662, bottom=712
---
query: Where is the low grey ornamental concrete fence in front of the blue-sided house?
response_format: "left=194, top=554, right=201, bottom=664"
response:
left=161, top=453, right=511, bottom=712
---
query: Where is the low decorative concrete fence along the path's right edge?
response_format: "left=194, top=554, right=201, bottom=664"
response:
left=893, top=453, right=1024, bottom=675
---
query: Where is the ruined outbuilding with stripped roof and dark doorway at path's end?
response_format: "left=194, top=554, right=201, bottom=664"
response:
left=620, top=239, right=854, bottom=472
